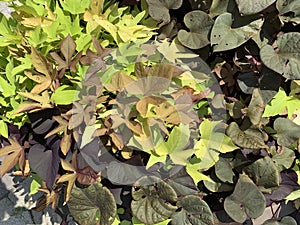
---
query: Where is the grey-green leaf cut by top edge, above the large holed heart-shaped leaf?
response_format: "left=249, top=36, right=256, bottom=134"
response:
left=235, top=0, right=276, bottom=15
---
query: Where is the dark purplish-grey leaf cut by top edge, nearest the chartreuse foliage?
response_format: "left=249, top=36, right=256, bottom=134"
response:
left=146, top=0, right=183, bottom=25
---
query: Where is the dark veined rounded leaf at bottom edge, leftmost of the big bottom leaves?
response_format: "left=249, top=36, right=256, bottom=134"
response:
left=67, top=182, right=117, bottom=225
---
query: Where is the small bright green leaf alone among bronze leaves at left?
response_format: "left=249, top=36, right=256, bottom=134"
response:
left=51, top=85, right=79, bottom=105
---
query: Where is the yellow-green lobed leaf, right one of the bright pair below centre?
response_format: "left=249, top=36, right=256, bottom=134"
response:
left=194, top=119, right=238, bottom=170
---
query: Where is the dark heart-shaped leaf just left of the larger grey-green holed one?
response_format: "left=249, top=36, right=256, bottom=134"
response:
left=178, top=10, right=214, bottom=49
